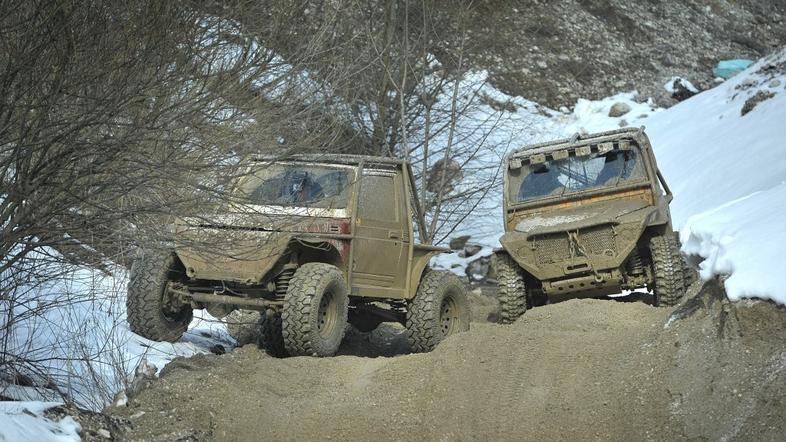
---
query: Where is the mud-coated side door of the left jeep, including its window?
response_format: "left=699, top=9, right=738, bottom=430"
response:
left=352, top=166, right=410, bottom=298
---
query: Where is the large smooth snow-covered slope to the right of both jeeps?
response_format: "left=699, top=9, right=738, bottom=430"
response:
left=647, top=50, right=786, bottom=304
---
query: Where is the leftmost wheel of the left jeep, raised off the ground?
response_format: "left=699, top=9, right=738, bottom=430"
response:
left=126, top=251, right=194, bottom=342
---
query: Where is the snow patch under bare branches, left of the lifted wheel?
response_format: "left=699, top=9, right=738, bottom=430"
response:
left=0, top=258, right=235, bottom=411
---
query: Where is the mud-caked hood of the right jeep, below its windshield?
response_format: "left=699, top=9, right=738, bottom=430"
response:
left=513, top=200, right=656, bottom=236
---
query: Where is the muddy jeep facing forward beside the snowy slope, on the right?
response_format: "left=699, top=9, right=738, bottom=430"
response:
left=494, top=129, right=685, bottom=323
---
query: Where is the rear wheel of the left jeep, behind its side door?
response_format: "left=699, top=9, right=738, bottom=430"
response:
left=406, top=270, right=470, bottom=353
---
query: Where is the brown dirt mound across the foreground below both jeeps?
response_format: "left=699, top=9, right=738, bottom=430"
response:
left=107, top=282, right=786, bottom=441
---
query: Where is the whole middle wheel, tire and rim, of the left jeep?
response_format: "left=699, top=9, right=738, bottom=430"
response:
left=281, top=262, right=349, bottom=357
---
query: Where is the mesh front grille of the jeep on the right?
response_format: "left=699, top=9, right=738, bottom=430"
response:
left=533, top=225, right=617, bottom=265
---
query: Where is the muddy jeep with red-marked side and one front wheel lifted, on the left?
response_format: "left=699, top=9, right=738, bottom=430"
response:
left=127, top=155, right=469, bottom=356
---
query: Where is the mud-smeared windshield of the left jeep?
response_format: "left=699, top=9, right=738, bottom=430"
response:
left=240, top=163, right=352, bottom=209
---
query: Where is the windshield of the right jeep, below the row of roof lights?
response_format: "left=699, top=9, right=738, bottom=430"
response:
left=508, top=149, right=646, bottom=203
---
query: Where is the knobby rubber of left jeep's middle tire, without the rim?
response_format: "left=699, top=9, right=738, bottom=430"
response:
left=281, top=262, right=349, bottom=357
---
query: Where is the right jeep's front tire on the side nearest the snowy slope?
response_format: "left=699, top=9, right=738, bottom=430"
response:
left=650, top=235, right=685, bottom=307
